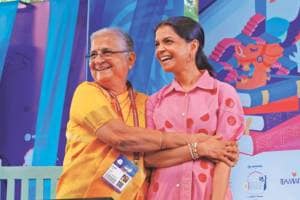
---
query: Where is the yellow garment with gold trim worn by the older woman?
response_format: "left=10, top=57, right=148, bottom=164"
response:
left=56, top=82, right=147, bottom=200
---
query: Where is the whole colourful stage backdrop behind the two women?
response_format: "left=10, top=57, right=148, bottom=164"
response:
left=0, top=0, right=300, bottom=200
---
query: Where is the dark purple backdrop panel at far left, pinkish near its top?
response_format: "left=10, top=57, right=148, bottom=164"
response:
left=0, top=2, right=49, bottom=165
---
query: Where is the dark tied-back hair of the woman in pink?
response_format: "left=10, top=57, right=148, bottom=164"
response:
left=154, top=16, right=214, bottom=76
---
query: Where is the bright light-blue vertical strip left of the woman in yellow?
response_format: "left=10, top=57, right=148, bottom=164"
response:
left=32, top=0, right=79, bottom=166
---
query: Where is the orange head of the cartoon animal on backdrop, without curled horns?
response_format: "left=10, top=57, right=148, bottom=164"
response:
left=234, top=44, right=283, bottom=89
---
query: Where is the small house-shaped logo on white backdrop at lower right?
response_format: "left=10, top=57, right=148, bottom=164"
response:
left=245, top=171, right=267, bottom=195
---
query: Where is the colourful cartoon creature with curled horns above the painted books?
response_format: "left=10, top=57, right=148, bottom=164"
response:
left=210, top=9, right=300, bottom=89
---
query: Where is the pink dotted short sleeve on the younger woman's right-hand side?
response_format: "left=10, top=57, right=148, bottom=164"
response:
left=217, top=83, right=245, bottom=140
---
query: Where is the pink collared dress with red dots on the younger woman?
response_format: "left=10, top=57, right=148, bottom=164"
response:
left=147, top=71, right=244, bottom=200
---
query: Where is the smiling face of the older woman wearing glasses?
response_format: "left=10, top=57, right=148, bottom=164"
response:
left=89, top=31, right=135, bottom=89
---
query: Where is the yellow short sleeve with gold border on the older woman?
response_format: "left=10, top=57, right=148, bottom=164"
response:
left=70, top=82, right=117, bottom=132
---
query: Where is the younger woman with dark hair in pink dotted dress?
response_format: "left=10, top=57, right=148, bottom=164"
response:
left=145, top=16, right=244, bottom=200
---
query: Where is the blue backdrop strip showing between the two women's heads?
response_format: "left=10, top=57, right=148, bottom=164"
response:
left=129, top=0, right=184, bottom=94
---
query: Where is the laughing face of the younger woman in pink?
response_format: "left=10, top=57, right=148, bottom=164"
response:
left=155, top=25, right=198, bottom=73
